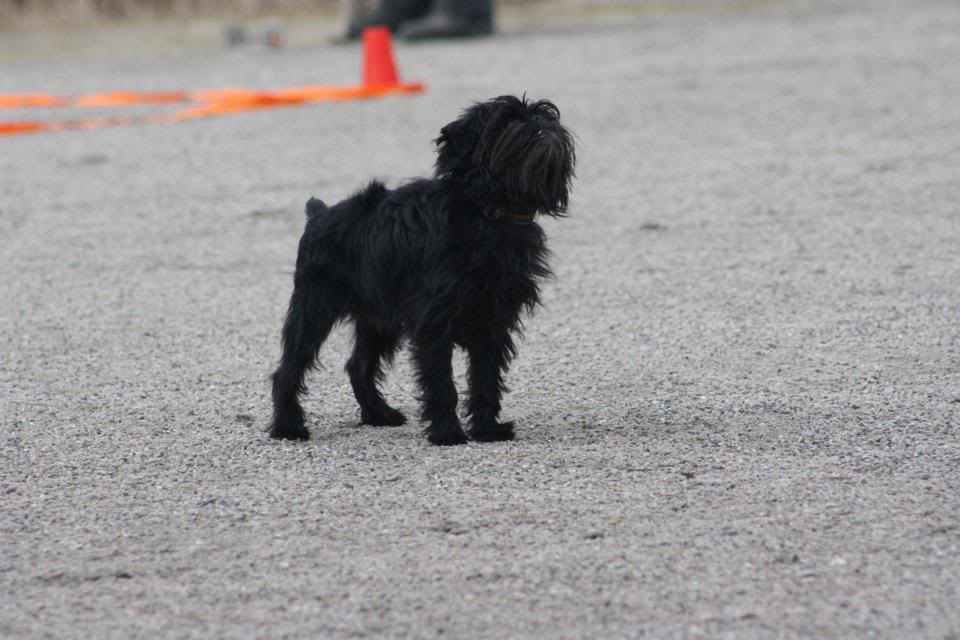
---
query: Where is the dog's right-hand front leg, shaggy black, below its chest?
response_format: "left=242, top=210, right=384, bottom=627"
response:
left=467, top=334, right=514, bottom=442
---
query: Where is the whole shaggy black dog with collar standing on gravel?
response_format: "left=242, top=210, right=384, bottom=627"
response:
left=270, top=96, right=575, bottom=445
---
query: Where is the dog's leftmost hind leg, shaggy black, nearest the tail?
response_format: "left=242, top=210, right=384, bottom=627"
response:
left=269, top=278, right=340, bottom=440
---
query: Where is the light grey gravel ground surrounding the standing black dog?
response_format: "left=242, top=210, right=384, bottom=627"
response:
left=0, top=0, right=960, bottom=640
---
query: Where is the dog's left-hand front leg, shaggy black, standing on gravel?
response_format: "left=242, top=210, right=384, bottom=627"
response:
left=413, top=331, right=467, bottom=445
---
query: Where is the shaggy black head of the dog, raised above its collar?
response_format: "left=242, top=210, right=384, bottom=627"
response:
left=436, top=96, right=576, bottom=216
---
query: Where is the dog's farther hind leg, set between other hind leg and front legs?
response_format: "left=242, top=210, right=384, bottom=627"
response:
left=346, top=320, right=407, bottom=427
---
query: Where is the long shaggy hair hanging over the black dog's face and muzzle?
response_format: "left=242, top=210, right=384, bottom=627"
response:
left=489, top=121, right=574, bottom=215
